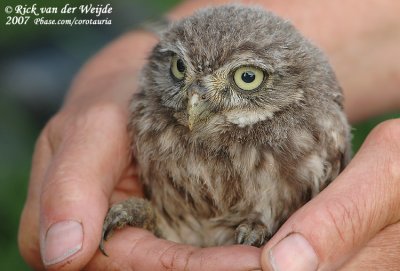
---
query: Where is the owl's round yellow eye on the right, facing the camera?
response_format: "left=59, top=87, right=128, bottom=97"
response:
left=233, top=66, right=264, bottom=90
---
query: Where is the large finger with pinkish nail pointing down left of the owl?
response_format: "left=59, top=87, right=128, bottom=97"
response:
left=40, top=105, right=129, bottom=270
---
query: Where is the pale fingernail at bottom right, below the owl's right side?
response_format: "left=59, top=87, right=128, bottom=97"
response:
left=269, top=233, right=318, bottom=271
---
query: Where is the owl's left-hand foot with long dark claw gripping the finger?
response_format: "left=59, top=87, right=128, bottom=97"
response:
left=99, top=198, right=161, bottom=256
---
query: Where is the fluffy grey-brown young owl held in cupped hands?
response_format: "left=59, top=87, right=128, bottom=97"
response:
left=100, top=5, right=350, bottom=255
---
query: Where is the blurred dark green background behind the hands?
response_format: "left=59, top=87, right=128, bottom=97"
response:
left=0, top=0, right=400, bottom=270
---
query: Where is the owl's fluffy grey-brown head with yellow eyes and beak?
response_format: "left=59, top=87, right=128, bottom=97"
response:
left=142, top=5, right=341, bottom=138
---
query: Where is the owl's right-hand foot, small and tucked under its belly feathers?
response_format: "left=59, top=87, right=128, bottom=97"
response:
left=236, top=220, right=271, bottom=247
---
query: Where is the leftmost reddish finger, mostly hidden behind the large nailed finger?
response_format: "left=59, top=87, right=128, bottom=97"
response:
left=18, top=132, right=52, bottom=270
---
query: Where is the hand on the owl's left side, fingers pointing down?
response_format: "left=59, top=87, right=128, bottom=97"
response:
left=18, top=31, right=142, bottom=269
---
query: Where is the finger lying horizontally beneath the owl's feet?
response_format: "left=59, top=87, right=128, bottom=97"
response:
left=85, top=228, right=261, bottom=271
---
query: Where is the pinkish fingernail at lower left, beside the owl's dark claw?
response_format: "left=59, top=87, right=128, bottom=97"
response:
left=42, top=220, right=83, bottom=266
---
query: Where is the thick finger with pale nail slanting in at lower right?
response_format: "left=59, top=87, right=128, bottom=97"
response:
left=262, top=120, right=400, bottom=271
